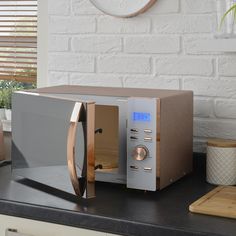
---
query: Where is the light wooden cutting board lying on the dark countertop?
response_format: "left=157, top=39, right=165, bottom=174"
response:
left=189, top=186, right=236, bottom=219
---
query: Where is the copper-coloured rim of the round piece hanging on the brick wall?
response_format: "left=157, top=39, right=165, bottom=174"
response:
left=90, top=0, right=157, bottom=18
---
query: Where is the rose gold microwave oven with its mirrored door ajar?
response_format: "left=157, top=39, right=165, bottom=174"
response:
left=12, top=85, right=193, bottom=198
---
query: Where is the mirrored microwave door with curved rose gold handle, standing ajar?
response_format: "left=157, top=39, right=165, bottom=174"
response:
left=12, top=92, right=95, bottom=198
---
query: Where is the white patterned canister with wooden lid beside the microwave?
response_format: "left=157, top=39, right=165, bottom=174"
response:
left=206, top=139, right=236, bottom=185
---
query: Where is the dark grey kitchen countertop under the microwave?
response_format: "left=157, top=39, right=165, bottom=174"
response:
left=0, top=155, right=236, bottom=236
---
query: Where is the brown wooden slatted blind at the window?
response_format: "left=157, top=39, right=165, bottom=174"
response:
left=0, top=0, right=36, bottom=82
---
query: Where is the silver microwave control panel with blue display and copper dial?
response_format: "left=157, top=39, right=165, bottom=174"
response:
left=127, top=98, right=157, bottom=191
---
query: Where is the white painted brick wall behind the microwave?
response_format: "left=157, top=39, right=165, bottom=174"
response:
left=48, top=0, right=236, bottom=152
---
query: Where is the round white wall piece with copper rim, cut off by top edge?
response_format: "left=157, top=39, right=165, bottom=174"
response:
left=90, top=0, right=156, bottom=17
